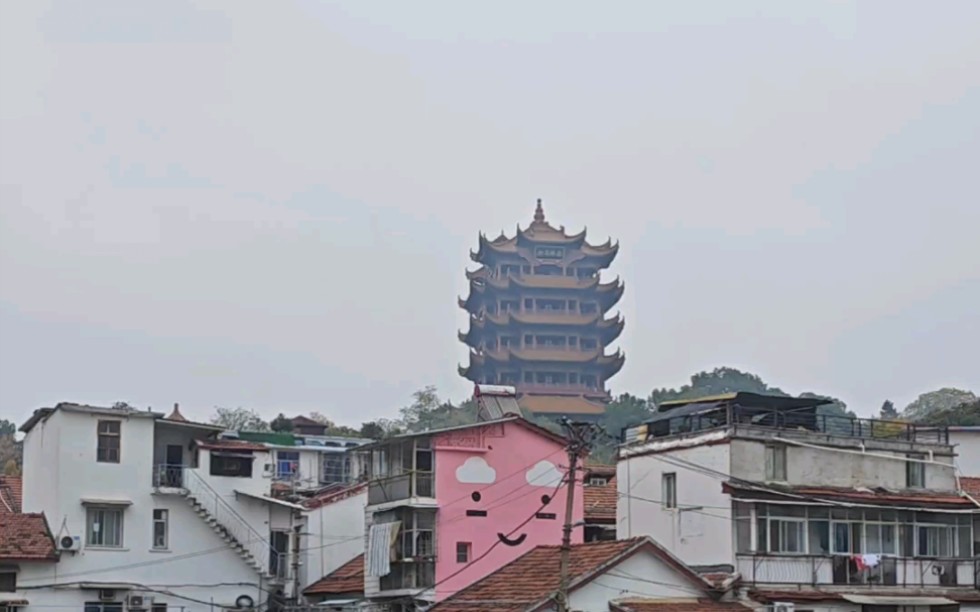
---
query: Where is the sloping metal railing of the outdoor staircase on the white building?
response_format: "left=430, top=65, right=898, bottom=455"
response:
left=182, top=467, right=289, bottom=579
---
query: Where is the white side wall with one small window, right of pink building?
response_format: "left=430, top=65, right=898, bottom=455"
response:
left=616, top=444, right=733, bottom=565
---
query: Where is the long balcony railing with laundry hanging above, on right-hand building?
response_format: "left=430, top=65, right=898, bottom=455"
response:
left=737, top=555, right=980, bottom=588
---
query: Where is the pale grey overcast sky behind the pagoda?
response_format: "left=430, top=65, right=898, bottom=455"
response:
left=0, top=0, right=980, bottom=424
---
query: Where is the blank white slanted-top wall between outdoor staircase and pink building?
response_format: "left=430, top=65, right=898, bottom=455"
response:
left=301, top=487, right=367, bottom=588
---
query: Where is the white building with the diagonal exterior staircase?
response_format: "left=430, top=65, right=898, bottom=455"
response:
left=16, top=403, right=318, bottom=612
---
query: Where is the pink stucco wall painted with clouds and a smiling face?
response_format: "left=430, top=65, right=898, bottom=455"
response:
left=433, top=423, right=584, bottom=599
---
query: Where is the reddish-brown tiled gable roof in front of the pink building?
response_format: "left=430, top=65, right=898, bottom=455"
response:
left=430, top=538, right=710, bottom=612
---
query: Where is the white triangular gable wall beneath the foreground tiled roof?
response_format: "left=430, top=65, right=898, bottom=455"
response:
left=569, top=551, right=712, bottom=612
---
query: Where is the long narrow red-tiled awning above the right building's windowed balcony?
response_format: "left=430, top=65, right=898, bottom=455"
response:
left=722, top=482, right=977, bottom=508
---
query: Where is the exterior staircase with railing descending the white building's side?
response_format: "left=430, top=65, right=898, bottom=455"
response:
left=153, top=466, right=288, bottom=586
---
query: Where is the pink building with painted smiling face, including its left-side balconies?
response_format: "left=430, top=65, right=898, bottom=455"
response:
left=358, top=416, right=584, bottom=602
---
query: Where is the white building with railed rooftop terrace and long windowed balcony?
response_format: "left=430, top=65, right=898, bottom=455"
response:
left=616, top=393, right=980, bottom=612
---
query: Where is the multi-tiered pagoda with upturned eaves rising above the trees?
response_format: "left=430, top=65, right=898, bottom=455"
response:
left=459, top=200, right=625, bottom=416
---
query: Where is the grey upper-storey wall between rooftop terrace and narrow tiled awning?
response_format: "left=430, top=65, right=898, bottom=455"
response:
left=731, top=439, right=956, bottom=491
